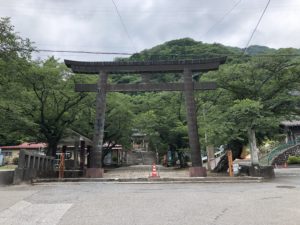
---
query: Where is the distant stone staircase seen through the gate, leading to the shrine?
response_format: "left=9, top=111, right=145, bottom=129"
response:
left=127, top=151, right=155, bottom=165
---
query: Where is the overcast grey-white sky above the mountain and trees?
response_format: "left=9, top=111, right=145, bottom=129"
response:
left=0, top=0, right=300, bottom=61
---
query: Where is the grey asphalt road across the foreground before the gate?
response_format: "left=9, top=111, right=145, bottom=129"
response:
left=0, top=174, right=300, bottom=225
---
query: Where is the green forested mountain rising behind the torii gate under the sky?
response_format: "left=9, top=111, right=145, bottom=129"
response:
left=112, top=38, right=300, bottom=83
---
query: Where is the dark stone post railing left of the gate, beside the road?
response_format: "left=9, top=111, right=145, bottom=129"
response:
left=14, top=150, right=55, bottom=184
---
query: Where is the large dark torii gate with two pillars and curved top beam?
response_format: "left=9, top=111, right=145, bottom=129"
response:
left=65, top=57, right=226, bottom=177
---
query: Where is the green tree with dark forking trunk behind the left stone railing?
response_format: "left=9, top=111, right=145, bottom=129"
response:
left=18, top=58, right=86, bottom=156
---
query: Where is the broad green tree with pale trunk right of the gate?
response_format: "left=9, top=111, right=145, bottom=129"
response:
left=202, top=49, right=300, bottom=164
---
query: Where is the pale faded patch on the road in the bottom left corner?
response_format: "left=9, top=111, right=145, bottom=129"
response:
left=0, top=201, right=72, bottom=225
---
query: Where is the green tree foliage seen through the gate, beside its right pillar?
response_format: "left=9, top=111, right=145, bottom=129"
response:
left=132, top=92, right=188, bottom=154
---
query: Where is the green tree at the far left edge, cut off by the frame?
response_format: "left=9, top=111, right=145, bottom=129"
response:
left=0, top=18, right=33, bottom=144
